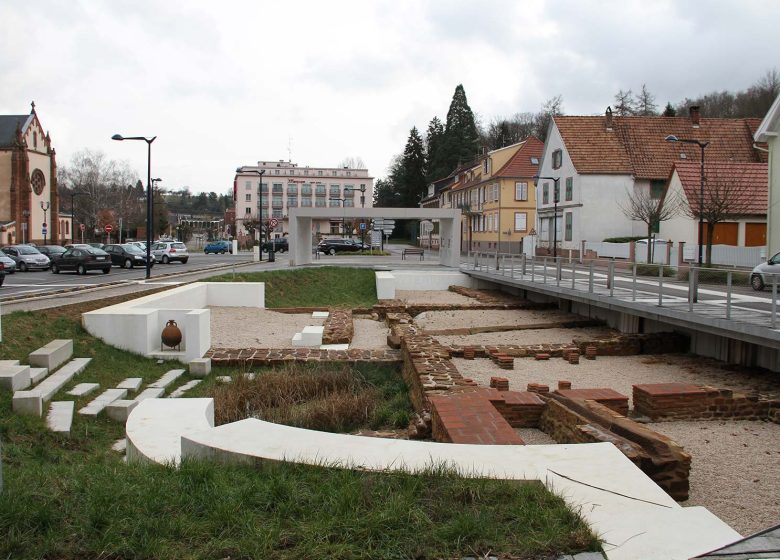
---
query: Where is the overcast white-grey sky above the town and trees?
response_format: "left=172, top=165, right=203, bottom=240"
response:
left=0, top=0, right=780, bottom=193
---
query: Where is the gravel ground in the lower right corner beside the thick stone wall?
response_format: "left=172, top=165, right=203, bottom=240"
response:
left=652, top=421, right=780, bottom=535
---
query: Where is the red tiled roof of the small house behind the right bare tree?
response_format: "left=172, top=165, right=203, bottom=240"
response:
left=672, top=162, right=769, bottom=216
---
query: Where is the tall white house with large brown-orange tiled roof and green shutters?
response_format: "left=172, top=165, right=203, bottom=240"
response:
left=536, top=107, right=765, bottom=251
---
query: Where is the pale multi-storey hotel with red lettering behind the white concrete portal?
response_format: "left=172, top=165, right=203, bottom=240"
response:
left=233, top=160, right=374, bottom=243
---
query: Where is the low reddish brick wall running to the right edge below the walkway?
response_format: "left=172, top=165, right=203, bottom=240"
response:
left=633, top=383, right=780, bottom=423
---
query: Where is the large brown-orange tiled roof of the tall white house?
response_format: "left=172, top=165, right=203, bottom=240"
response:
left=555, top=116, right=763, bottom=179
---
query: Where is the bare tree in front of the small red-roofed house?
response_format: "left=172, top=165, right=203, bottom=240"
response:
left=682, top=165, right=755, bottom=264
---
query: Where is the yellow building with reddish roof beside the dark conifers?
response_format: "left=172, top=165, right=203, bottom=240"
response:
left=440, top=136, right=544, bottom=254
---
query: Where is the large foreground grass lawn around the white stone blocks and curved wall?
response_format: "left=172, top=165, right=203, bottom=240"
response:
left=0, top=282, right=599, bottom=559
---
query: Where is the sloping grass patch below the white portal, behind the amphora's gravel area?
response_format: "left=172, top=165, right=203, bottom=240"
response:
left=208, top=266, right=377, bottom=308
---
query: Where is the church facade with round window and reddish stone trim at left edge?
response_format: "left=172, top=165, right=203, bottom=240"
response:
left=0, top=103, right=60, bottom=245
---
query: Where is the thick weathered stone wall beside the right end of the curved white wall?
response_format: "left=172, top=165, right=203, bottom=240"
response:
left=539, top=393, right=691, bottom=501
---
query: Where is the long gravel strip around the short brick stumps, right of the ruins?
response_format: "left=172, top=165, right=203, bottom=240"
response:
left=450, top=354, right=780, bottom=399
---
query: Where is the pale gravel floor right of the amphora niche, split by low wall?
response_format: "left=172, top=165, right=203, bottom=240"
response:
left=210, top=307, right=388, bottom=349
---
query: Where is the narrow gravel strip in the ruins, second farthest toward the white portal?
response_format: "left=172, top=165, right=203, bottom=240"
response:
left=415, top=309, right=583, bottom=330
